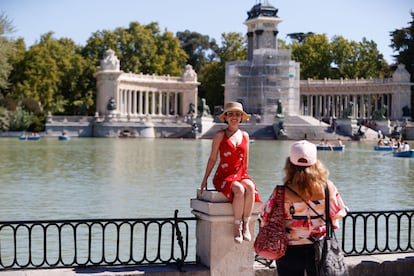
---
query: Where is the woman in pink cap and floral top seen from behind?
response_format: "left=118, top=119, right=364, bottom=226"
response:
left=261, top=140, right=348, bottom=276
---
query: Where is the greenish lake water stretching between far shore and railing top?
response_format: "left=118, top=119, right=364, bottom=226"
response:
left=0, top=138, right=414, bottom=220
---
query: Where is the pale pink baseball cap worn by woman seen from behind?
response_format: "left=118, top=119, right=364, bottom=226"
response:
left=289, top=140, right=318, bottom=167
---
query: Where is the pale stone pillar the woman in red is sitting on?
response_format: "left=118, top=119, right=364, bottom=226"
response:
left=191, top=190, right=262, bottom=276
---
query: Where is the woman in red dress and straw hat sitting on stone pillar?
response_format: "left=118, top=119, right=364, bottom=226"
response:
left=200, top=102, right=261, bottom=243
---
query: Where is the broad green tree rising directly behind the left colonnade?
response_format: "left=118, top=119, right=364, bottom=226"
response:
left=82, top=22, right=188, bottom=76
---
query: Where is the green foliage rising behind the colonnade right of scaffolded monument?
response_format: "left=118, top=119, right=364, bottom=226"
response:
left=292, top=34, right=390, bottom=79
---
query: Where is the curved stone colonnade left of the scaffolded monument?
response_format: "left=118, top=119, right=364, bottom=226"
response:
left=94, top=50, right=200, bottom=121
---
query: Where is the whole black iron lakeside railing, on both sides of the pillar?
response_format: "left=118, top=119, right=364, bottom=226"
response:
left=0, top=210, right=414, bottom=270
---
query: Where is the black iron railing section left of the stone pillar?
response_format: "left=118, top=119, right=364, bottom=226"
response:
left=0, top=210, right=196, bottom=269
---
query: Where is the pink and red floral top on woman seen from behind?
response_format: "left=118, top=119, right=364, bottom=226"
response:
left=261, top=181, right=347, bottom=245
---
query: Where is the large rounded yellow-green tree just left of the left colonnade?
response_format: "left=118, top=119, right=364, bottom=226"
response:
left=8, top=32, right=95, bottom=116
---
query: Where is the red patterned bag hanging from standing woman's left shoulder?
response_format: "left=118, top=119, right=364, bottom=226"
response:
left=254, top=185, right=288, bottom=260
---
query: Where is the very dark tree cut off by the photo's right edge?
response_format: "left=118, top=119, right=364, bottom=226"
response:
left=390, top=11, right=414, bottom=117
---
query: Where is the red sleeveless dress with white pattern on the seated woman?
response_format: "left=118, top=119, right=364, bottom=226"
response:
left=213, top=134, right=261, bottom=202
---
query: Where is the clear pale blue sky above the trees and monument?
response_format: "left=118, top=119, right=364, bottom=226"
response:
left=0, top=0, right=414, bottom=63
